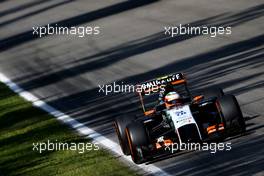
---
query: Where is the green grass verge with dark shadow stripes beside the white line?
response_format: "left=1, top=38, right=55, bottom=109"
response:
left=0, top=83, right=136, bottom=176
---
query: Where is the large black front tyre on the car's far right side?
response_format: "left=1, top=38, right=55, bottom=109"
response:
left=219, top=95, right=246, bottom=135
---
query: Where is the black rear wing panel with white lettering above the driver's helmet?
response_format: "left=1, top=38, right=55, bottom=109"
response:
left=137, top=73, right=186, bottom=95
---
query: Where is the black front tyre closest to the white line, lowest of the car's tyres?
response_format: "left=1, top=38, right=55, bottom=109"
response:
left=126, top=122, right=149, bottom=164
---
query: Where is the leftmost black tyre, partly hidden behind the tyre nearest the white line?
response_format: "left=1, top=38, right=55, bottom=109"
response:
left=114, top=116, right=135, bottom=155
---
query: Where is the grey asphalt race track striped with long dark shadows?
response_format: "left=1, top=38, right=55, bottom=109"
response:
left=0, top=0, right=264, bottom=175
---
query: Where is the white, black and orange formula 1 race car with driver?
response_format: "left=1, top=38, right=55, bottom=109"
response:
left=114, top=73, right=245, bottom=164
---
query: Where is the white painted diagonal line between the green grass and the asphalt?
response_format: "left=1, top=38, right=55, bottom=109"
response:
left=0, top=73, right=169, bottom=176
